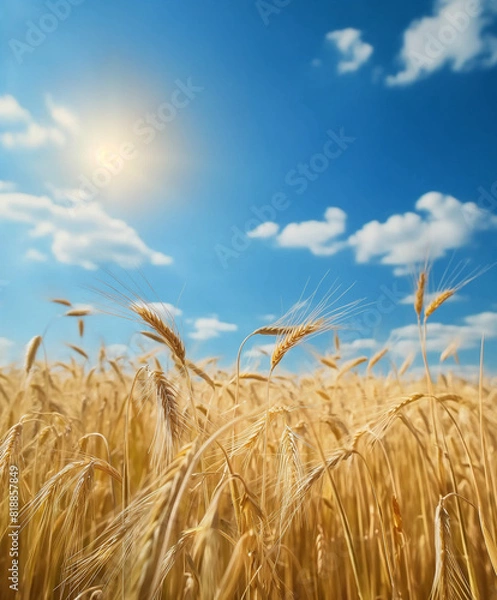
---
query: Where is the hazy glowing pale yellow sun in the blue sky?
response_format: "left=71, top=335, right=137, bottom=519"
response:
left=58, top=98, right=184, bottom=210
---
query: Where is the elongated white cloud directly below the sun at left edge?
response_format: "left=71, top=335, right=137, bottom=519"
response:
left=0, top=194, right=172, bottom=269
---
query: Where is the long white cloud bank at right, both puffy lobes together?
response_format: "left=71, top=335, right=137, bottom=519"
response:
left=245, top=192, right=497, bottom=272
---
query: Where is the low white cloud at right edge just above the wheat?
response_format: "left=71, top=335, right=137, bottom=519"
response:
left=387, top=312, right=497, bottom=356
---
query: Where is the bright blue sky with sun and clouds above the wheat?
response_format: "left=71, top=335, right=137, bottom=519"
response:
left=0, top=0, right=497, bottom=371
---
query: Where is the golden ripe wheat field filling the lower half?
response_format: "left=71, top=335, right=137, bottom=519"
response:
left=0, top=290, right=497, bottom=600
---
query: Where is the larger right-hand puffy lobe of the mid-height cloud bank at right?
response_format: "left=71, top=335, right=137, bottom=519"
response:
left=348, top=192, right=497, bottom=266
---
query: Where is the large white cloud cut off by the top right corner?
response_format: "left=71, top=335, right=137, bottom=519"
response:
left=386, top=0, right=497, bottom=86
